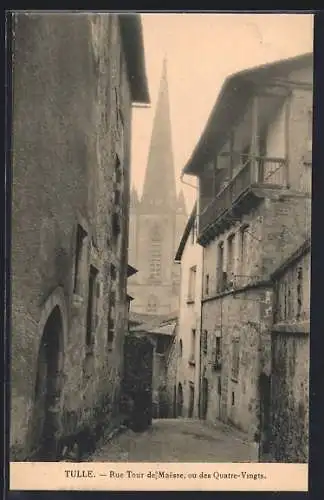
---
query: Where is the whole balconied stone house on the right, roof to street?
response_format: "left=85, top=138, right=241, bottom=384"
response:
left=183, top=54, right=313, bottom=450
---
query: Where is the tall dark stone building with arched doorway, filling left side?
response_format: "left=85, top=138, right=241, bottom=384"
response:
left=11, top=13, right=149, bottom=460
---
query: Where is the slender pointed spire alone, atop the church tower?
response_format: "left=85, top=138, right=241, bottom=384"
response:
left=141, top=58, right=177, bottom=212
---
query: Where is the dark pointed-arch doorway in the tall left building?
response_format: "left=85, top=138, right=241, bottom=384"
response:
left=31, top=306, right=63, bottom=461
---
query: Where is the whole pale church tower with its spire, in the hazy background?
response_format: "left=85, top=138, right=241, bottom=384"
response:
left=128, top=60, right=187, bottom=315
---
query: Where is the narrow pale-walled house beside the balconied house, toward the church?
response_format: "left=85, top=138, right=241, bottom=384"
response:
left=175, top=204, right=203, bottom=418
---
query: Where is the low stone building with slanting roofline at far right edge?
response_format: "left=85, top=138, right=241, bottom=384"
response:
left=268, top=239, right=311, bottom=462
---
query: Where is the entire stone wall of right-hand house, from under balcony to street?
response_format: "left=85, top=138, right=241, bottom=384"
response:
left=201, top=193, right=310, bottom=438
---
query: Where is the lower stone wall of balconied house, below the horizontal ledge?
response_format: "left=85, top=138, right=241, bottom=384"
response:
left=201, top=288, right=271, bottom=439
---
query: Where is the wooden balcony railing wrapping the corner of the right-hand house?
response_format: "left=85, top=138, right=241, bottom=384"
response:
left=199, top=155, right=287, bottom=242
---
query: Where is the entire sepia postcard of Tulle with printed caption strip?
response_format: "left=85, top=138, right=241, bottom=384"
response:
left=10, top=11, right=313, bottom=491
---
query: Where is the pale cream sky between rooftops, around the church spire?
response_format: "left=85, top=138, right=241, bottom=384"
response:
left=131, top=13, right=314, bottom=211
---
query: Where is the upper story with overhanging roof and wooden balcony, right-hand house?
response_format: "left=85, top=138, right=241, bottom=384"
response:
left=183, top=53, right=313, bottom=245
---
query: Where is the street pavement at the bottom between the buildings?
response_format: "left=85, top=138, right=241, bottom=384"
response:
left=89, top=419, right=257, bottom=462
